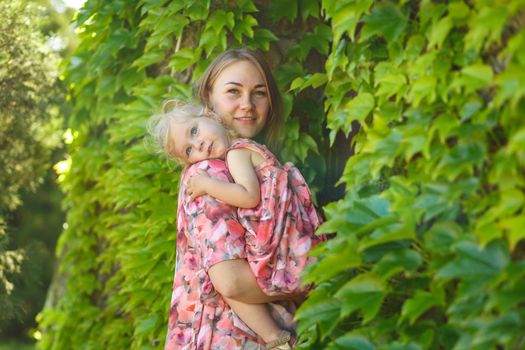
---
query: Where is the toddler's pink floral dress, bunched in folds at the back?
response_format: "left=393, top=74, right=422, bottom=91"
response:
left=229, top=138, right=324, bottom=295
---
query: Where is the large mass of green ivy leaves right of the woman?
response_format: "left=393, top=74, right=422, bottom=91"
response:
left=298, top=1, right=525, bottom=349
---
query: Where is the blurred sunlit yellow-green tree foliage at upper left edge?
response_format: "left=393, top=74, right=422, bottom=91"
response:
left=0, top=1, right=58, bottom=214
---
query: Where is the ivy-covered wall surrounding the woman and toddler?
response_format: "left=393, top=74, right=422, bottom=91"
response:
left=39, top=0, right=525, bottom=349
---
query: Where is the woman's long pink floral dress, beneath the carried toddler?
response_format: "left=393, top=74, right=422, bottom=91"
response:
left=165, top=160, right=256, bottom=350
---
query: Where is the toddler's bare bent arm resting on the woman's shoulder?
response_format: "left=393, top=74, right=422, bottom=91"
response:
left=186, top=149, right=260, bottom=208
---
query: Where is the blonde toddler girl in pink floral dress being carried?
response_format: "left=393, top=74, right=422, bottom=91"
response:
left=145, top=100, right=321, bottom=349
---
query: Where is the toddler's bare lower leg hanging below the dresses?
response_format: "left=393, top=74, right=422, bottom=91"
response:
left=224, top=298, right=281, bottom=343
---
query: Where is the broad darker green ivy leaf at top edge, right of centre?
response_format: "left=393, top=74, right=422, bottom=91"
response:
left=360, top=3, right=407, bottom=42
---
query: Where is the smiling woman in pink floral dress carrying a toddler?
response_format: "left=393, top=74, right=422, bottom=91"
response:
left=166, top=49, right=302, bottom=350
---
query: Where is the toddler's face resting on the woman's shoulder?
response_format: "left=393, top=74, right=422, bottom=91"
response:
left=170, top=117, right=230, bottom=164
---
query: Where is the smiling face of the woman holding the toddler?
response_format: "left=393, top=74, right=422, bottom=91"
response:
left=210, top=61, right=270, bottom=138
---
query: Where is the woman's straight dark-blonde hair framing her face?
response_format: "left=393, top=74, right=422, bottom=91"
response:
left=197, top=48, right=284, bottom=151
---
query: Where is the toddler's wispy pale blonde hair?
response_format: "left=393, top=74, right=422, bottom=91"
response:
left=147, top=99, right=238, bottom=164
